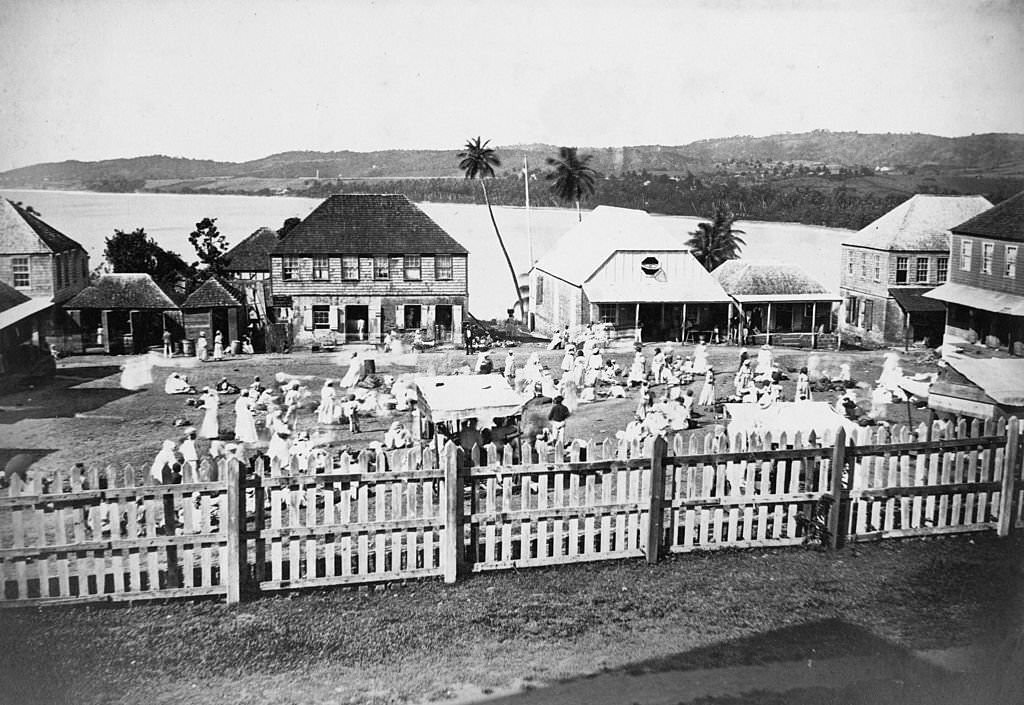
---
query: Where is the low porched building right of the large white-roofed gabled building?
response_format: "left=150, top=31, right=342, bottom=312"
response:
left=712, top=259, right=840, bottom=347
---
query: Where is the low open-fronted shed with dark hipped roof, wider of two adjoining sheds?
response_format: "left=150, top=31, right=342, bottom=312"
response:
left=63, top=274, right=181, bottom=354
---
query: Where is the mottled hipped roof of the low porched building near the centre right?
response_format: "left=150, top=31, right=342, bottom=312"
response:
left=712, top=259, right=839, bottom=301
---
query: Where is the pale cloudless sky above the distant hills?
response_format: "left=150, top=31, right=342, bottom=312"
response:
left=0, top=0, right=1024, bottom=170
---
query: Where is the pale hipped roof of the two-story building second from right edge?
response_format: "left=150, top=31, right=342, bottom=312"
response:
left=843, top=194, right=992, bottom=252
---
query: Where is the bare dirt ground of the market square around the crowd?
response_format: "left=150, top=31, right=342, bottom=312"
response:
left=0, top=343, right=937, bottom=471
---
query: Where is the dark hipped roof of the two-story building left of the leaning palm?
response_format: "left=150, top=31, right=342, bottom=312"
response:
left=273, top=194, right=468, bottom=255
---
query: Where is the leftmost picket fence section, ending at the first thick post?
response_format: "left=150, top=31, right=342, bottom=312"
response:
left=0, top=464, right=226, bottom=605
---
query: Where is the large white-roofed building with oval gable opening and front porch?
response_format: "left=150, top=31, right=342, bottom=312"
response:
left=529, top=206, right=731, bottom=340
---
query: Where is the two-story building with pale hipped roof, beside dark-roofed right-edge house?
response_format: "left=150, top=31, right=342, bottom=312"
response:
left=839, top=194, right=992, bottom=345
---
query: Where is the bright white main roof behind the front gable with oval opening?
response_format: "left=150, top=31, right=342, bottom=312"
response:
left=535, top=206, right=689, bottom=286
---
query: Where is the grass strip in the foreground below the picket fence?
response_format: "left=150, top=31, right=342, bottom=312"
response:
left=0, top=535, right=1024, bottom=705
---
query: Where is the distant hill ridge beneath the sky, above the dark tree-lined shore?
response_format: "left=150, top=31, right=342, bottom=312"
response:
left=8, top=130, right=1024, bottom=191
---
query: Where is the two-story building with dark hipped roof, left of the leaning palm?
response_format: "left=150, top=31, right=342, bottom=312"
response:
left=270, top=194, right=469, bottom=343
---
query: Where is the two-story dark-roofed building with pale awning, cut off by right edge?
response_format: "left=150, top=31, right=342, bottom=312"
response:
left=927, top=193, right=1024, bottom=356
